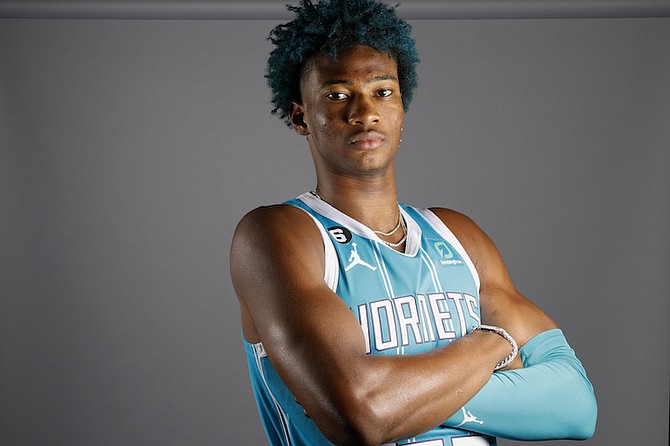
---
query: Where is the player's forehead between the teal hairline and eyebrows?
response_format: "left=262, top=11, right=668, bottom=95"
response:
left=301, top=46, right=398, bottom=88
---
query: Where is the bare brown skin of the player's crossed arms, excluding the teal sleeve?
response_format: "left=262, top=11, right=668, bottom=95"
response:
left=231, top=205, right=600, bottom=444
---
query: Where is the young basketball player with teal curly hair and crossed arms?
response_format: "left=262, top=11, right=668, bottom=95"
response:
left=231, top=0, right=597, bottom=446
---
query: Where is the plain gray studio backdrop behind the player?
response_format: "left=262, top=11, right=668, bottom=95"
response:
left=0, top=2, right=670, bottom=446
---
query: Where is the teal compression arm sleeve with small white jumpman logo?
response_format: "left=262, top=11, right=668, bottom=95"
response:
left=444, top=329, right=598, bottom=440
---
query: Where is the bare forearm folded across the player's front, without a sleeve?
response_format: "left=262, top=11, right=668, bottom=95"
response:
left=306, top=332, right=509, bottom=444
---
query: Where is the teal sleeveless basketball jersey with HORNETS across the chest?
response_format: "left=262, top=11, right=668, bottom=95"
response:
left=245, top=193, right=495, bottom=446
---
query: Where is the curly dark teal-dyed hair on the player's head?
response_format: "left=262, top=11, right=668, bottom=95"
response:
left=265, top=0, right=419, bottom=126
